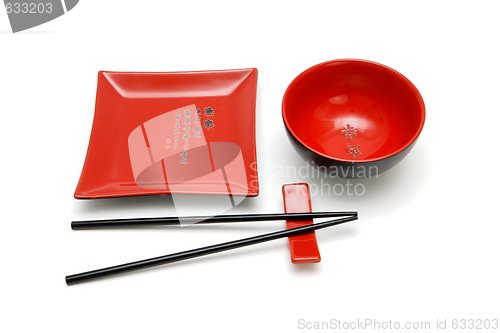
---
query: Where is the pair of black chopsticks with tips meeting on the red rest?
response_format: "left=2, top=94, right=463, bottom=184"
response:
left=66, top=212, right=358, bottom=285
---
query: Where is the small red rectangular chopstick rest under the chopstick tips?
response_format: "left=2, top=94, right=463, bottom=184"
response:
left=282, top=183, right=321, bottom=264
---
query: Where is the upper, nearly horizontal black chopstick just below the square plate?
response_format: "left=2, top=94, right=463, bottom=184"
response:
left=71, top=212, right=357, bottom=230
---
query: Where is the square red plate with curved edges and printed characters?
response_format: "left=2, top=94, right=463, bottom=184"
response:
left=75, top=68, right=259, bottom=199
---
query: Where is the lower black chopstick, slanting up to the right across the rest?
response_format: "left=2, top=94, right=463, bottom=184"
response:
left=66, top=216, right=358, bottom=285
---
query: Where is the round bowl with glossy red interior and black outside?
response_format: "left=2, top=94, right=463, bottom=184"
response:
left=282, top=59, right=425, bottom=178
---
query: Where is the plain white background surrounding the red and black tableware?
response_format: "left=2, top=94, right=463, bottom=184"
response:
left=0, top=0, right=500, bottom=332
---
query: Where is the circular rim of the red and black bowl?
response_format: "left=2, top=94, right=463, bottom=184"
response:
left=281, top=58, right=426, bottom=163
